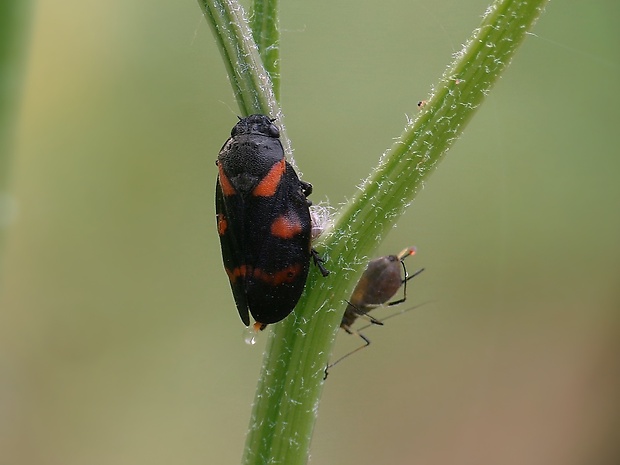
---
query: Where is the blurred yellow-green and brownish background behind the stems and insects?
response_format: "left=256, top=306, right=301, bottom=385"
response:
left=0, top=0, right=620, bottom=465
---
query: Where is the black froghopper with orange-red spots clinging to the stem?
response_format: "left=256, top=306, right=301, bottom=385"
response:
left=215, top=115, right=328, bottom=329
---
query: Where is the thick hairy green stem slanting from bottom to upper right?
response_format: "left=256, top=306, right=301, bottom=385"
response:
left=199, top=0, right=546, bottom=465
